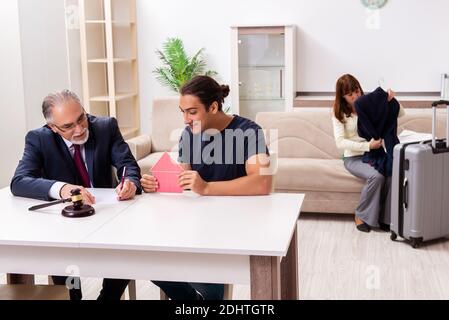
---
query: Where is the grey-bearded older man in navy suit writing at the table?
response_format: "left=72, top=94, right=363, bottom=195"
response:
left=11, top=90, right=142, bottom=300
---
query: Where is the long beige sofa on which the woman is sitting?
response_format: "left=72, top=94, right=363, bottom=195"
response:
left=256, top=108, right=446, bottom=213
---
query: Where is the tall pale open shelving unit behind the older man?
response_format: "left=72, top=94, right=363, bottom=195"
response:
left=79, top=0, right=140, bottom=139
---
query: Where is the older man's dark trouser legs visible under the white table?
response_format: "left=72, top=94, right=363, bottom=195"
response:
left=52, top=276, right=129, bottom=301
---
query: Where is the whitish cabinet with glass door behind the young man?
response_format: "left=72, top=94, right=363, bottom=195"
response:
left=231, top=25, right=296, bottom=120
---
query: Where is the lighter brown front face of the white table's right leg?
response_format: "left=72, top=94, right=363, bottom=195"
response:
left=250, top=256, right=281, bottom=300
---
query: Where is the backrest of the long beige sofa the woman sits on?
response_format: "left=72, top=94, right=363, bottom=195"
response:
left=256, top=108, right=446, bottom=159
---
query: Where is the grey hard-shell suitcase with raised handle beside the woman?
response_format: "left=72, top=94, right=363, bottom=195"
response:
left=390, top=100, right=449, bottom=248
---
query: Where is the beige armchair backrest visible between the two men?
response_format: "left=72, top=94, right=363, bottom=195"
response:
left=151, top=97, right=185, bottom=152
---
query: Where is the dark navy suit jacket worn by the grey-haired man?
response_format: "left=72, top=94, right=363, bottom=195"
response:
left=11, top=115, right=142, bottom=200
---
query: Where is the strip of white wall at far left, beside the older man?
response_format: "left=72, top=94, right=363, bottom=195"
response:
left=0, top=0, right=26, bottom=187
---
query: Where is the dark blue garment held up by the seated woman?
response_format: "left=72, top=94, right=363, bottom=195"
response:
left=355, top=87, right=399, bottom=177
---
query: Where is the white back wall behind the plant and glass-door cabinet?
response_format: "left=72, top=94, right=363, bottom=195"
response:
left=137, top=0, right=449, bottom=132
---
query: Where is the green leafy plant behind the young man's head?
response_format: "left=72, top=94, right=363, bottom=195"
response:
left=153, top=38, right=217, bottom=93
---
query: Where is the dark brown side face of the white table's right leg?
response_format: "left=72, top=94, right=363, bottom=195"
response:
left=281, top=227, right=299, bottom=300
